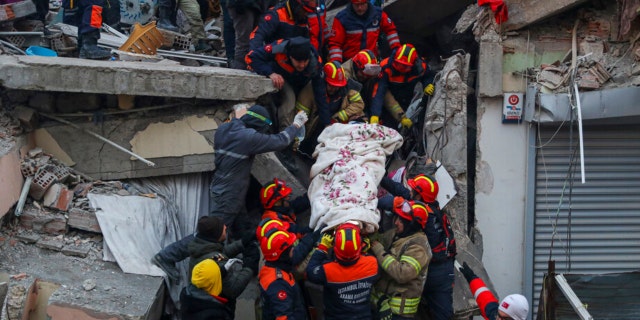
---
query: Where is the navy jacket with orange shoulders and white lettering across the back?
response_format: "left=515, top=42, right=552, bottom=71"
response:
left=307, top=249, right=379, bottom=320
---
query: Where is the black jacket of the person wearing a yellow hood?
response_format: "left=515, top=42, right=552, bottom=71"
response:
left=180, top=283, right=234, bottom=320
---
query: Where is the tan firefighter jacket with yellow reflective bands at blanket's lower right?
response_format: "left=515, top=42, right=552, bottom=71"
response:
left=371, top=229, right=431, bottom=317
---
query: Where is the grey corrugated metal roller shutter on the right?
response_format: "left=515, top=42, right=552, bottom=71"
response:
left=527, top=125, right=640, bottom=314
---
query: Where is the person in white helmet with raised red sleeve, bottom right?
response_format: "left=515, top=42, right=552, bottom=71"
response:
left=459, top=262, right=529, bottom=320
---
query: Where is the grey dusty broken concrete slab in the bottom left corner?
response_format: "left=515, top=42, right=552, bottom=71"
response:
left=0, top=240, right=164, bottom=320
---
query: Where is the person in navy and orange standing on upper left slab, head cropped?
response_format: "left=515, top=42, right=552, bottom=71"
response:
left=62, top=0, right=111, bottom=60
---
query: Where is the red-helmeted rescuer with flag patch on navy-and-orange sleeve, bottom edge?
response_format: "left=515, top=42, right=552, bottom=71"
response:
left=258, top=230, right=307, bottom=320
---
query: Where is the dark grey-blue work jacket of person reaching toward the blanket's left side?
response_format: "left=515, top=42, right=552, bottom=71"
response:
left=209, top=119, right=298, bottom=218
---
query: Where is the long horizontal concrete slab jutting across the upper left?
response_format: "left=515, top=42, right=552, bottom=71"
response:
left=0, top=55, right=275, bottom=101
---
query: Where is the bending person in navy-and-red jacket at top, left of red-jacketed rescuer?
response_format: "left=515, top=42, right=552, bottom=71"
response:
left=249, top=0, right=331, bottom=53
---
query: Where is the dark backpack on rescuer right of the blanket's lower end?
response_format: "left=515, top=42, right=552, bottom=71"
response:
left=424, top=201, right=457, bottom=262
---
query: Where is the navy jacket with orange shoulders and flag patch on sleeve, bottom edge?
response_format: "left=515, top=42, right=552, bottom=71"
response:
left=258, top=262, right=307, bottom=320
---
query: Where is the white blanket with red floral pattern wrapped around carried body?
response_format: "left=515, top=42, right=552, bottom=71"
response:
left=309, top=124, right=402, bottom=233
